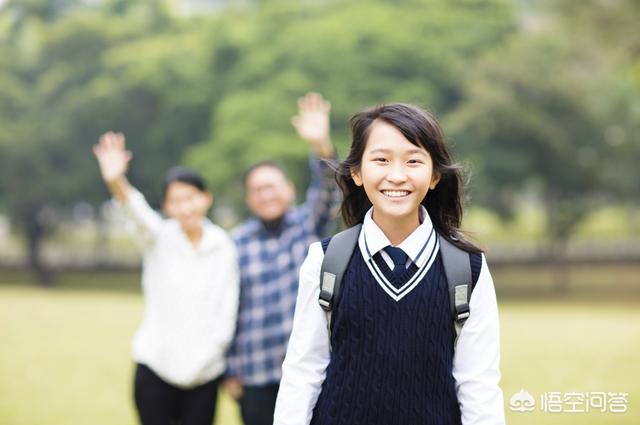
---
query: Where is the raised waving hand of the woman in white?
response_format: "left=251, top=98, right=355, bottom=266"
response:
left=93, top=131, right=133, bottom=184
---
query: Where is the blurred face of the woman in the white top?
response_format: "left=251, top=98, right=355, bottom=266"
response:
left=163, top=181, right=213, bottom=233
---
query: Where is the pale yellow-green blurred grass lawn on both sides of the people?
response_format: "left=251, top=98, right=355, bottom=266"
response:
left=0, top=278, right=640, bottom=425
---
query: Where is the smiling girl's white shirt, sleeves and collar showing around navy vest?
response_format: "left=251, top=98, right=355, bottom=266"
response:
left=274, top=210, right=504, bottom=425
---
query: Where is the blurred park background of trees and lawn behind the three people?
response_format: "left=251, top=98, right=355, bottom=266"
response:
left=0, top=0, right=640, bottom=424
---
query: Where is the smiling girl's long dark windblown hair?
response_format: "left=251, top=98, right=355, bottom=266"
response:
left=336, top=103, right=481, bottom=252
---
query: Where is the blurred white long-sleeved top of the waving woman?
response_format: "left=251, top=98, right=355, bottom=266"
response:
left=117, top=190, right=239, bottom=388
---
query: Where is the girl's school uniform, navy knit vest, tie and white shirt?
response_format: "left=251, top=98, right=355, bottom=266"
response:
left=274, top=208, right=504, bottom=425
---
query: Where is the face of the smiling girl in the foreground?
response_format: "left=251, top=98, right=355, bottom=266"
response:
left=351, top=120, right=439, bottom=225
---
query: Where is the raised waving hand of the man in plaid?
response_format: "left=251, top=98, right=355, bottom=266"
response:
left=291, top=92, right=333, bottom=157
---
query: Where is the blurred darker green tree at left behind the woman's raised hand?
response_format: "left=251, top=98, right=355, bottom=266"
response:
left=0, top=2, right=211, bottom=284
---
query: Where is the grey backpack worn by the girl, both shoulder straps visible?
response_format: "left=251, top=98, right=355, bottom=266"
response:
left=318, top=224, right=475, bottom=347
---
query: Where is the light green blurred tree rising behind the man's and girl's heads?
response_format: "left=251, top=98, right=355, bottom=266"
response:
left=186, top=0, right=515, bottom=209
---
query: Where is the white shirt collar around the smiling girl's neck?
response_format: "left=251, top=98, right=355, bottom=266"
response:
left=358, top=205, right=436, bottom=267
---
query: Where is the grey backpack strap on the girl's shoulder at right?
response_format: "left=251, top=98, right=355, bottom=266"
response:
left=438, top=235, right=473, bottom=340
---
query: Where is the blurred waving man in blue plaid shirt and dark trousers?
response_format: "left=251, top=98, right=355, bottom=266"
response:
left=225, top=93, right=340, bottom=425
